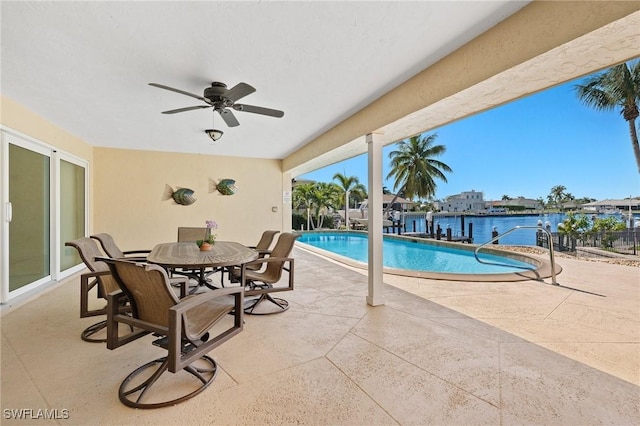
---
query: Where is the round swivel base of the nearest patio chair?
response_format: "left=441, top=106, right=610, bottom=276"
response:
left=118, top=355, right=218, bottom=409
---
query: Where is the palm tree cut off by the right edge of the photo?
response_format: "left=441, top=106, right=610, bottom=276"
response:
left=575, top=60, right=640, bottom=172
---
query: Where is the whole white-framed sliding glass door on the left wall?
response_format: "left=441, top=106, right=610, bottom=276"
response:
left=0, top=128, right=87, bottom=302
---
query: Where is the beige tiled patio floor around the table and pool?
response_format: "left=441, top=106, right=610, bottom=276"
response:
left=0, top=245, right=640, bottom=425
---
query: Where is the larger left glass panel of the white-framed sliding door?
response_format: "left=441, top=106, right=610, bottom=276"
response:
left=8, top=143, right=51, bottom=292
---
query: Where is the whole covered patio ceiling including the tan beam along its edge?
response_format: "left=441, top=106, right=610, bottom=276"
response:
left=0, top=0, right=640, bottom=176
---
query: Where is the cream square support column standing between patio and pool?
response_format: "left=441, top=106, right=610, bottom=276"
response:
left=366, top=133, right=384, bottom=306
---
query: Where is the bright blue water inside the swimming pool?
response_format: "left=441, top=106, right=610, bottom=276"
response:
left=298, top=232, right=535, bottom=274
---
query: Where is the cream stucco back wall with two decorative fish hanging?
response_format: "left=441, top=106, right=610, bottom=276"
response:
left=93, top=148, right=290, bottom=250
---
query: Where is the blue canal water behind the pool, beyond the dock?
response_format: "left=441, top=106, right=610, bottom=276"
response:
left=404, top=213, right=640, bottom=246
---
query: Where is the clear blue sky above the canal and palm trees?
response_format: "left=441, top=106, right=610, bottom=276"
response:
left=296, top=71, right=640, bottom=200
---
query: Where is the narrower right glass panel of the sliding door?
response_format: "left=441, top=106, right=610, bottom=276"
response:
left=59, top=160, right=86, bottom=271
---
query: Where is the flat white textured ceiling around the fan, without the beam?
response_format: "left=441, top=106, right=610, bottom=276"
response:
left=1, top=0, right=529, bottom=159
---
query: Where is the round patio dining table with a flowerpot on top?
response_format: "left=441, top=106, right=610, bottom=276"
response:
left=147, top=241, right=258, bottom=289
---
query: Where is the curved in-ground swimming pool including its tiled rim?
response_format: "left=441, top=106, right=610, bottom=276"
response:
left=297, top=231, right=544, bottom=281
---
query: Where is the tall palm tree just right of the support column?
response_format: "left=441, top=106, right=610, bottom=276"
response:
left=385, top=134, right=452, bottom=215
